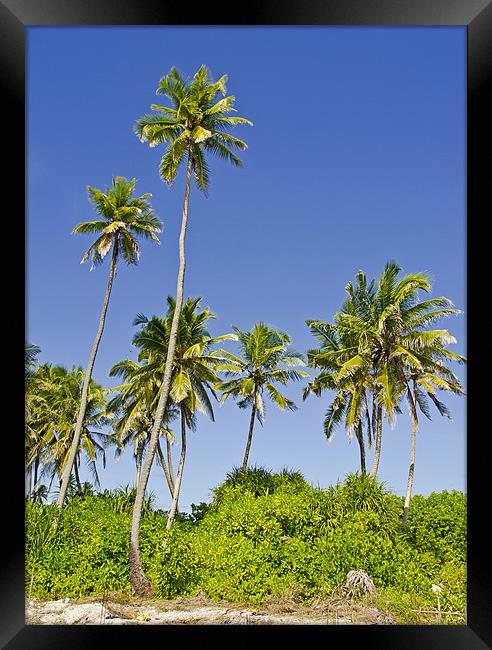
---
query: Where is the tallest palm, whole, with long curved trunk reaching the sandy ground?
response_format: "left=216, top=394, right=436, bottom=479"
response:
left=129, top=65, right=252, bottom=595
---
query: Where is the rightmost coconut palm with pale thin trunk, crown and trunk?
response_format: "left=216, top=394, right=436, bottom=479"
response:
left=343, top=260, right=466, bottom=522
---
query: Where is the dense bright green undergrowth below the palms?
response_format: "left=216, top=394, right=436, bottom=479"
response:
left=26, top=468, right=466, bottom=622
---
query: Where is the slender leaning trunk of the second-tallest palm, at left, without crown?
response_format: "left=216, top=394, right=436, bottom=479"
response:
left=56, top=239, right=118, bottom=509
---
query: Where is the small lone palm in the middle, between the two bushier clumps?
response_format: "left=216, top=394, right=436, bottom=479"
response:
left=215, top=323, right=308, bottom=471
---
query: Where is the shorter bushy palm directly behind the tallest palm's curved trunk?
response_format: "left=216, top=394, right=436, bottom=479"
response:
left=111, top=296, right=235, bottom=540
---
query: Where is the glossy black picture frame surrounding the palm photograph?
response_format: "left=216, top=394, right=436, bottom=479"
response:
left=4, top=0, right=492, bottom=650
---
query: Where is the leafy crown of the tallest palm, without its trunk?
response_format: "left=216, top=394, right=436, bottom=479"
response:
left=135, top=65, right=252, bottom=193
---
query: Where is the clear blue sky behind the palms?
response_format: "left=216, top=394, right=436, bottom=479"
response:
left=26, top=27, right=466, bottom=510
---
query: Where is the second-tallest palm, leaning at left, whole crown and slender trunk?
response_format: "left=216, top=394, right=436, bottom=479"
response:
left=56, top=176, right=161, bottom=508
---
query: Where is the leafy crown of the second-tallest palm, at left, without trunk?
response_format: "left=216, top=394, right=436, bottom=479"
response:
left=73, top=176, right=162, bottom=271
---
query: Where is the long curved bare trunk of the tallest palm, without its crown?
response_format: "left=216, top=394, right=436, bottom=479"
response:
left=129, top=151, right=193, bottom=596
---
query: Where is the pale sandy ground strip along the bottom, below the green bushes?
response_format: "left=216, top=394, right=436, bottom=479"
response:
left=26, top=595, right=395, bottom=625
